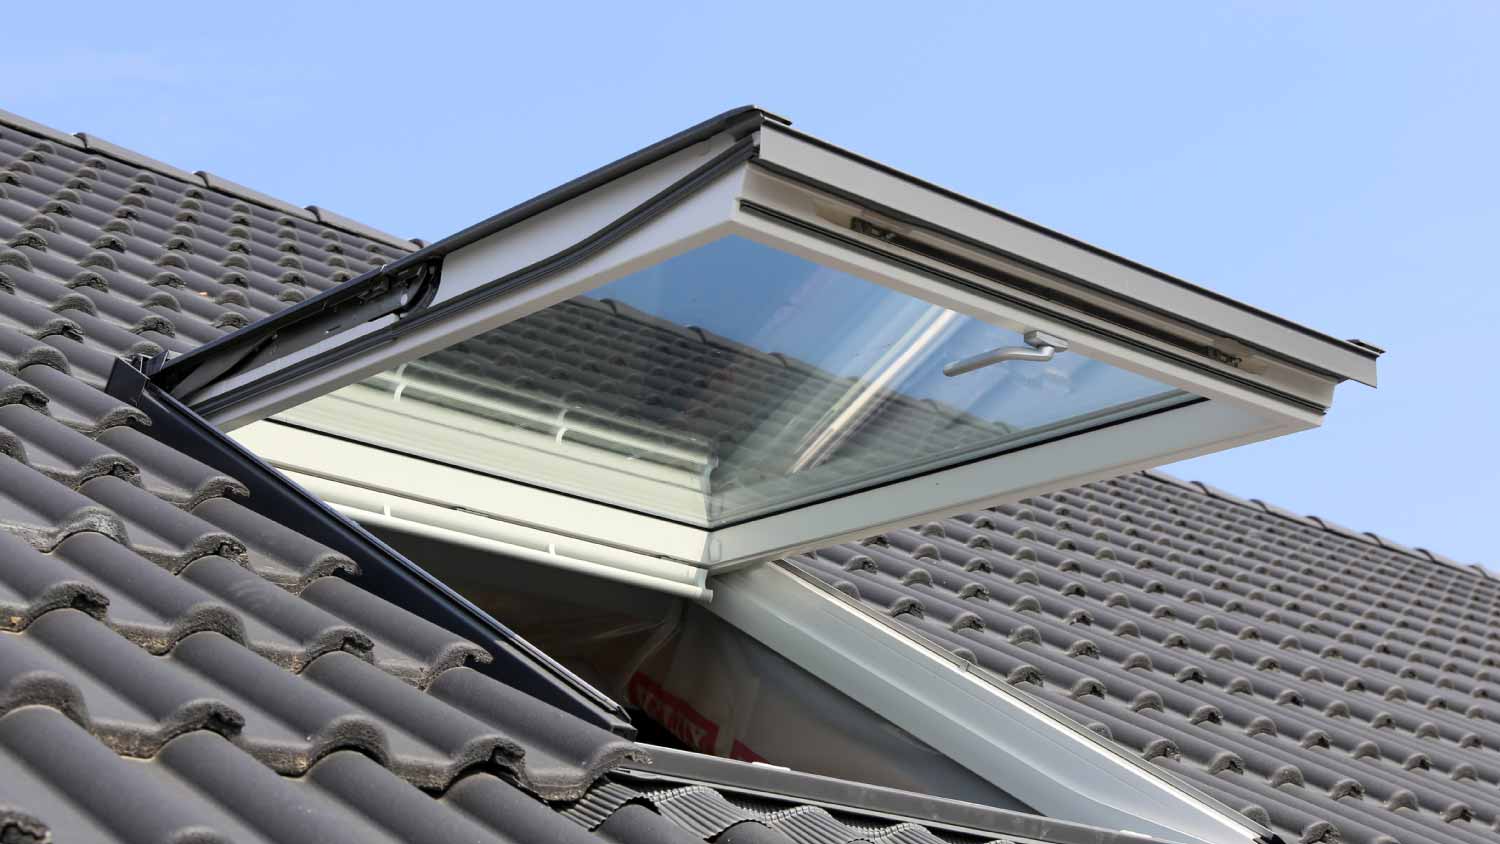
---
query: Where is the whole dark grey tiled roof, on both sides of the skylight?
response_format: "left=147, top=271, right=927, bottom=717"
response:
left=0, top=104, right=1482, bottom=844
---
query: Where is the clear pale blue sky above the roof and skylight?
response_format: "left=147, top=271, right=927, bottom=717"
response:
left=0, top=0, right=1500, bottom=567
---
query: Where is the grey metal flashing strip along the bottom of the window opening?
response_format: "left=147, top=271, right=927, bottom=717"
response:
left=611, top=745, right=1167, bottom=844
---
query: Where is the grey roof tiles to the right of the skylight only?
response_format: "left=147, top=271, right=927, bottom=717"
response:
left=798, top=474, right=1500, bottom=844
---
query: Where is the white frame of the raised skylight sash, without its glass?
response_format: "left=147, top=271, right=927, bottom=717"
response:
left=198, top=115, right=1374, bottom=570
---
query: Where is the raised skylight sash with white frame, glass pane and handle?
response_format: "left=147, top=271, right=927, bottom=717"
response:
left=161, top=109, right=1379, bottom=566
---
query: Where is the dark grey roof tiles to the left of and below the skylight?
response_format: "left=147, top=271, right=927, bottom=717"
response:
left=0, top=112, right=1146, bottom=844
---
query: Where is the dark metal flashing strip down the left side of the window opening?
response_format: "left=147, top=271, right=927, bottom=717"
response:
left=107, top=360, right=635, bottom=738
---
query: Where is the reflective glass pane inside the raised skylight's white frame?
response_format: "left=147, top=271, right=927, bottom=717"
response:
left=278, top=237, right=1193, bottom=528
